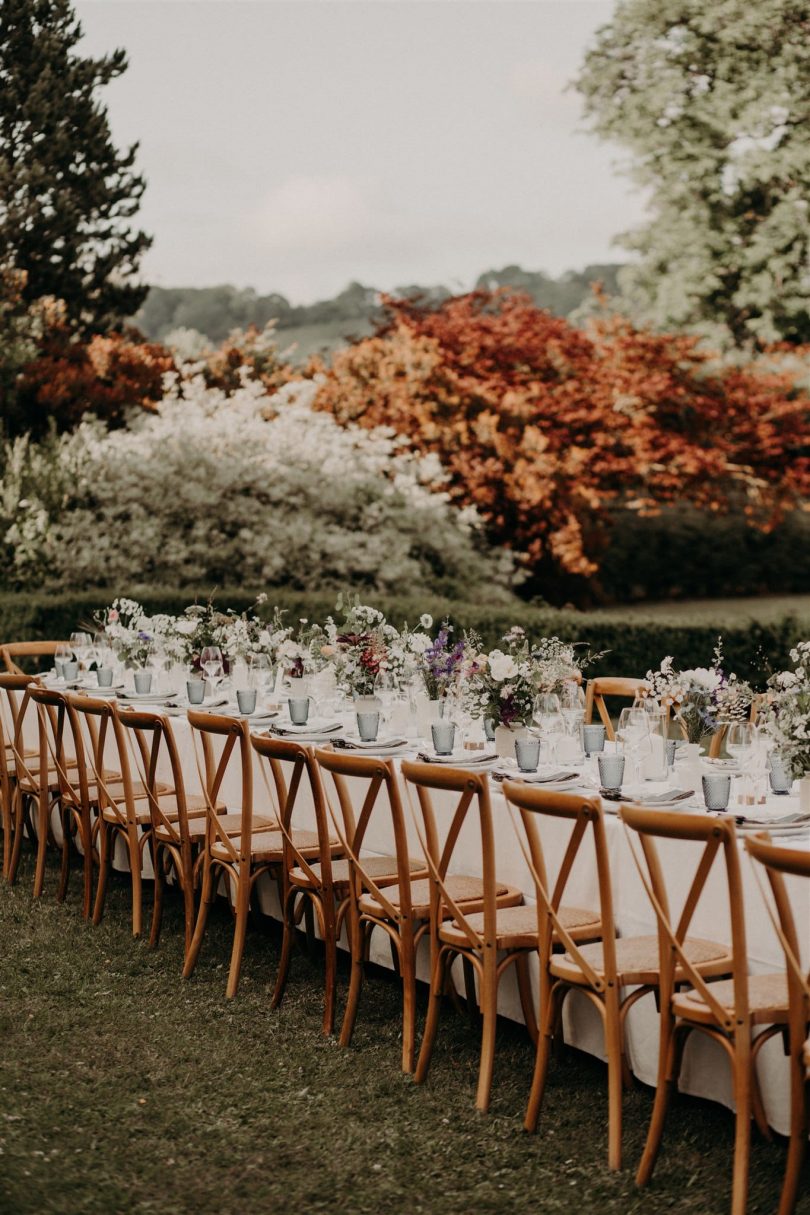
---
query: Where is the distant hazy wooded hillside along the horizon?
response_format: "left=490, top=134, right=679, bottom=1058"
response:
left=134, top=262, right=621, bottom=358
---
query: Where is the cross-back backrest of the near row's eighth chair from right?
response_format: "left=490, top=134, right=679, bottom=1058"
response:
left=113, top=706, right=192, bottom=860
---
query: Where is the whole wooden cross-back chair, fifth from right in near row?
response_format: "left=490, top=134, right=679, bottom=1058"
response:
left=315, top=748, right=429, bottom=1073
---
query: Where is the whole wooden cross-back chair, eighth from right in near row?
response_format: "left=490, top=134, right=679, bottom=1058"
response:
left=115, top=708, right=218, bottom=965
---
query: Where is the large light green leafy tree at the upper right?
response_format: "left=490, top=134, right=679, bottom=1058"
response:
left=577, top=0, right=810, bottom=346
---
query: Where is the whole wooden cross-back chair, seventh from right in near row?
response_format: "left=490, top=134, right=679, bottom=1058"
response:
left=183, top=710, right=283, bottom=999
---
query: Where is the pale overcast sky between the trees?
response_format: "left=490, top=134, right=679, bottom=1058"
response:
left=75, top=0, right=641, bottom=303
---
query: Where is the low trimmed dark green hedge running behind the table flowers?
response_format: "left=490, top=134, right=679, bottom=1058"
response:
left=0, top=587, right=810, bottom=685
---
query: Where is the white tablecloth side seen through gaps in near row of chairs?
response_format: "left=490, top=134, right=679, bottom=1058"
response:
left=75, top=717, right=810, bottom=1134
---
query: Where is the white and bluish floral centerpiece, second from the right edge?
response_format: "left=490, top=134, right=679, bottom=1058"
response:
left=642, top=640, right=754, bottom=744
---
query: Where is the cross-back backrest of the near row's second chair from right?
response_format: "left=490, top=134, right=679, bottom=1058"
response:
left=619, top=806, right=748, bottom=1033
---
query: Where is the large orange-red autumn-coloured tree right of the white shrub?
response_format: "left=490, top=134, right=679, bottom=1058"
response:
left=317, top=290, right=810, bottom=592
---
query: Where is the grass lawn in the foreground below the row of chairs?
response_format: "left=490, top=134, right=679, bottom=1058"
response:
left=0, top=859, right=810, bottom=1215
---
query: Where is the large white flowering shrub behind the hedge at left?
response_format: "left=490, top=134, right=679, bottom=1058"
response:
left=0, top=373, right=510, bottom=597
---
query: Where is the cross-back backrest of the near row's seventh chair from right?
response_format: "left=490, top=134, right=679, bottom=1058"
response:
left=188, top=708, right=253, bottom=869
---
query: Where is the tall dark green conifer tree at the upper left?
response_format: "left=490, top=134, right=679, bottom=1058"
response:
left=0, top=0, right=152, bottom=333
